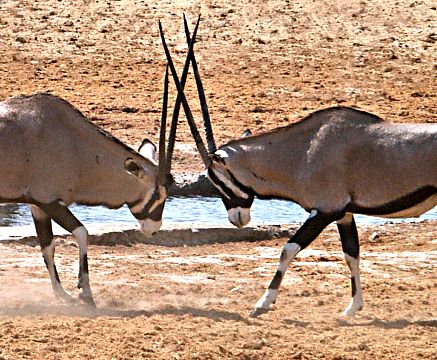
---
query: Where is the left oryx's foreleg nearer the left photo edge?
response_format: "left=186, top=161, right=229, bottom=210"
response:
left=31, top=205, right=74, bottom=302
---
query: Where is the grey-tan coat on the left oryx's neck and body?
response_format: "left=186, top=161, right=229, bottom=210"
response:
left=0, top=94, right=158, bottom=207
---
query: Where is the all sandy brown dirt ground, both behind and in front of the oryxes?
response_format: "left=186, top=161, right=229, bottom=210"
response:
left=0, top=0, right=437, bottom=359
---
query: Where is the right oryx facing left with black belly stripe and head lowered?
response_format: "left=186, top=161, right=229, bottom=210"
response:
left=161, top=16, right=437, bottom=317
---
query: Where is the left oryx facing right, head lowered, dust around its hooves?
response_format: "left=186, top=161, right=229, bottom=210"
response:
left=0, top=64, right=175, bottom=306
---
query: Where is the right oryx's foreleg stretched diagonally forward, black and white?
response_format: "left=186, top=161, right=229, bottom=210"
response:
left=250, top=210, right=338, bottom=317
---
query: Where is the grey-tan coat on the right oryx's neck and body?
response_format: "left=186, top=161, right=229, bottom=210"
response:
left=216, top=108, right=437, bottom=215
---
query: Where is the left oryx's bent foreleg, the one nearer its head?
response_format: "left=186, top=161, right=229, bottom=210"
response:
left=40, top=202, right=95, bottom=306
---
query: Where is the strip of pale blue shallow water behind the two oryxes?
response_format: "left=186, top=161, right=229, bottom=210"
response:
left=0, top=197, right=437, bottom=238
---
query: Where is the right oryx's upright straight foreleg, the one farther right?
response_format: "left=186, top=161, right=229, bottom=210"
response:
left=337, top=214, right=363, bottom=316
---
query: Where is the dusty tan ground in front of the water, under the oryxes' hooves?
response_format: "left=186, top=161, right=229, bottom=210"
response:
left=0, top=222, right=437, bottom=359
